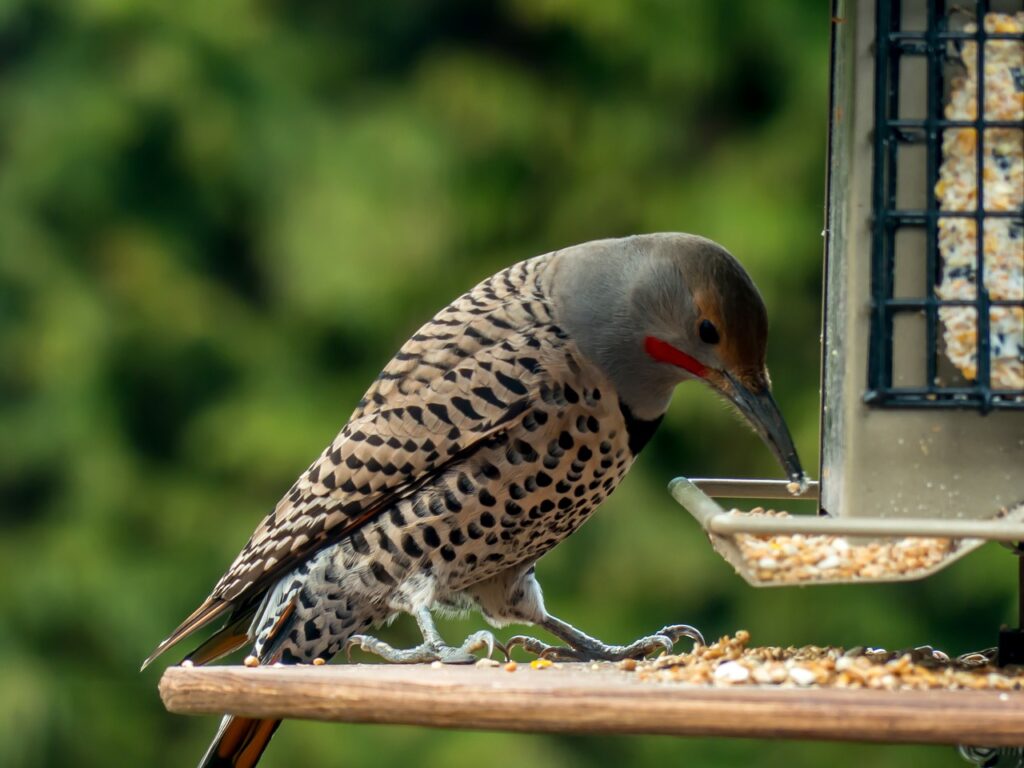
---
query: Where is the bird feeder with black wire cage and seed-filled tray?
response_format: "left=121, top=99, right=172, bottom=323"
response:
left=672, top=0, right=1024, bottom=630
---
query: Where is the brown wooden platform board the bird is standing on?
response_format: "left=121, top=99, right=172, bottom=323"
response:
left=160, top=664, right=1024, bottom=746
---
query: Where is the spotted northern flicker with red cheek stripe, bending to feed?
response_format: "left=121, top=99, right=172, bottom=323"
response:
left=145, top=233, right=804, bottom=766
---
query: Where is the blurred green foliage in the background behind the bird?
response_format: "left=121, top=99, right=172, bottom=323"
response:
left=0, top=0, right=1014, bottom=768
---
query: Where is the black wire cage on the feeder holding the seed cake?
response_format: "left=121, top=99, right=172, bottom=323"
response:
left=865, top=0, right=1024, bottom=413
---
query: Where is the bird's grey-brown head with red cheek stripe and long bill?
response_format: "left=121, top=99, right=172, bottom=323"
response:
left=553, top=232, right=805, bottom=483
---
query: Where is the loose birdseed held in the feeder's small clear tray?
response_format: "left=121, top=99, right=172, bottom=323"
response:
left=730, top=507, right=954, bottom=584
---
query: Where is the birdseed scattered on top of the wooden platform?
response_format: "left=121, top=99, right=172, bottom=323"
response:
left=624, top=630, right=1024, bottom=691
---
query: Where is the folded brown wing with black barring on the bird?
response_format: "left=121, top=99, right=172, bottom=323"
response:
left=146, top=260, right=564, bottom=664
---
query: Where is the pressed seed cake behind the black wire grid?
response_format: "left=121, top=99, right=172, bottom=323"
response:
left=935, top=12, right=1024, bottom=389
